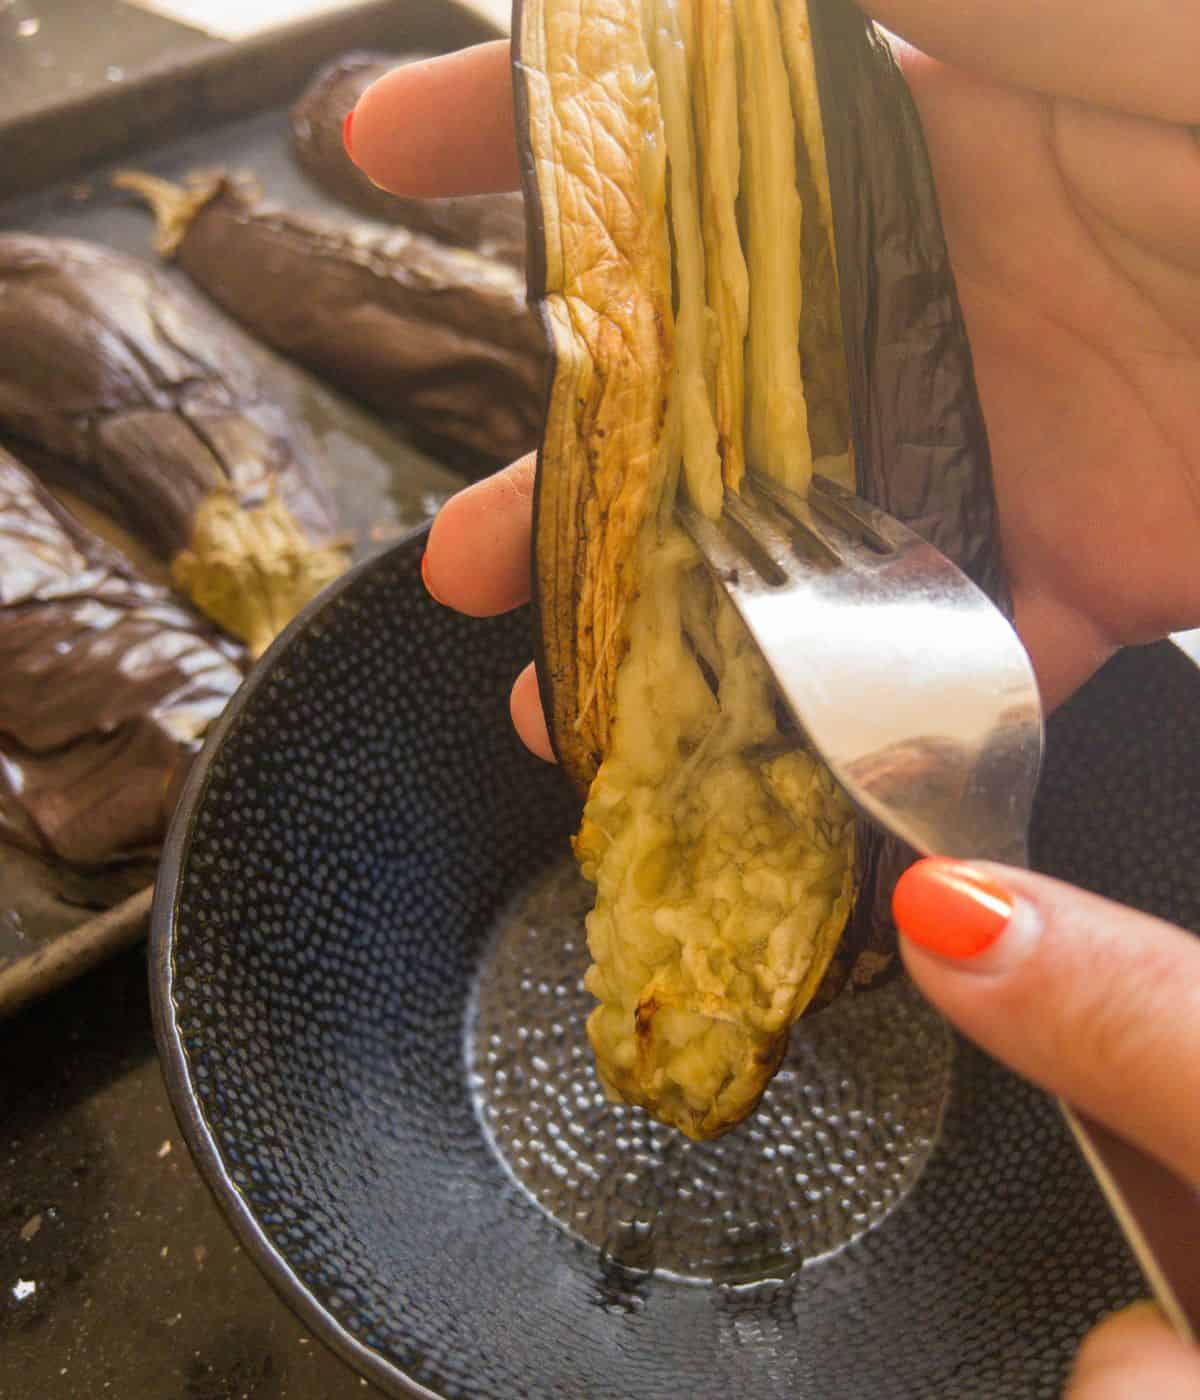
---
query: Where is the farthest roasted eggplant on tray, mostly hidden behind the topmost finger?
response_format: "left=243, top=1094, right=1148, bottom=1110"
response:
left=290, top=53, right=525, bottom=270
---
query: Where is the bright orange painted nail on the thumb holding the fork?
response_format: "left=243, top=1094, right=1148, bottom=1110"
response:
left=892, top=855, right=1040, bottom=972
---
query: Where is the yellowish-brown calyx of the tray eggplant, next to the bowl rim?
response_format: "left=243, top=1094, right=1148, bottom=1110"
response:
left=171, top=489, right=349, bottom=658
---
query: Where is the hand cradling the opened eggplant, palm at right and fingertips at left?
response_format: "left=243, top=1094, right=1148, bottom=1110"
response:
left=344, top=10, right=1200, bottom=756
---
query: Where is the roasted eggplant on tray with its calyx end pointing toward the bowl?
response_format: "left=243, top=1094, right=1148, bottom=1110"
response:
left=0, top=234, right=346, bottom=654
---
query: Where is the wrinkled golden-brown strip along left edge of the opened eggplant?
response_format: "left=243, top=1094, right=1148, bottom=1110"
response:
left=514, top=0, right=675, bottom=792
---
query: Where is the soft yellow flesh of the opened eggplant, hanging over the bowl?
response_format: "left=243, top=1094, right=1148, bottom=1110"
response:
left=518, top=0, right=854, bottom=1138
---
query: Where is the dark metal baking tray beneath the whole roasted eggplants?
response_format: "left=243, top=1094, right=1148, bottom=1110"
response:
left=0, top=0, right=497, bottom=1016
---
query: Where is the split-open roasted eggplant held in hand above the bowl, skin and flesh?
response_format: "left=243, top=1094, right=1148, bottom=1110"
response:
left=514, top=0, right=1000, bottom=1137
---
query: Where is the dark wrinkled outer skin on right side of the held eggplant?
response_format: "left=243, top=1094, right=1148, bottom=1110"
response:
left=808, top=0, right=1010, bottom=1000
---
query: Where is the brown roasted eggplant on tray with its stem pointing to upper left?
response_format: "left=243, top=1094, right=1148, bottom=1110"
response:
left=116, top=172, right=545, bottom=466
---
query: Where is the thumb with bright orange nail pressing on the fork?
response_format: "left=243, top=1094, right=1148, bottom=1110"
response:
left=893, top=858, right=1200, bottom=1182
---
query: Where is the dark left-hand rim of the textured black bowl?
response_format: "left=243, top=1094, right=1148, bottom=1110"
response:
left=147, top=522, right=431, bottom=1400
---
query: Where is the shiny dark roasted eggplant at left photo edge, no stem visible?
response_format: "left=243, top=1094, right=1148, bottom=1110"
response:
left=0, top=449, right=246, bottom=867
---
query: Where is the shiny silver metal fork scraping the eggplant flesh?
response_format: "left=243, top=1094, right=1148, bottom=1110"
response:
left=676, top=476, right=1200, bottom=1341
